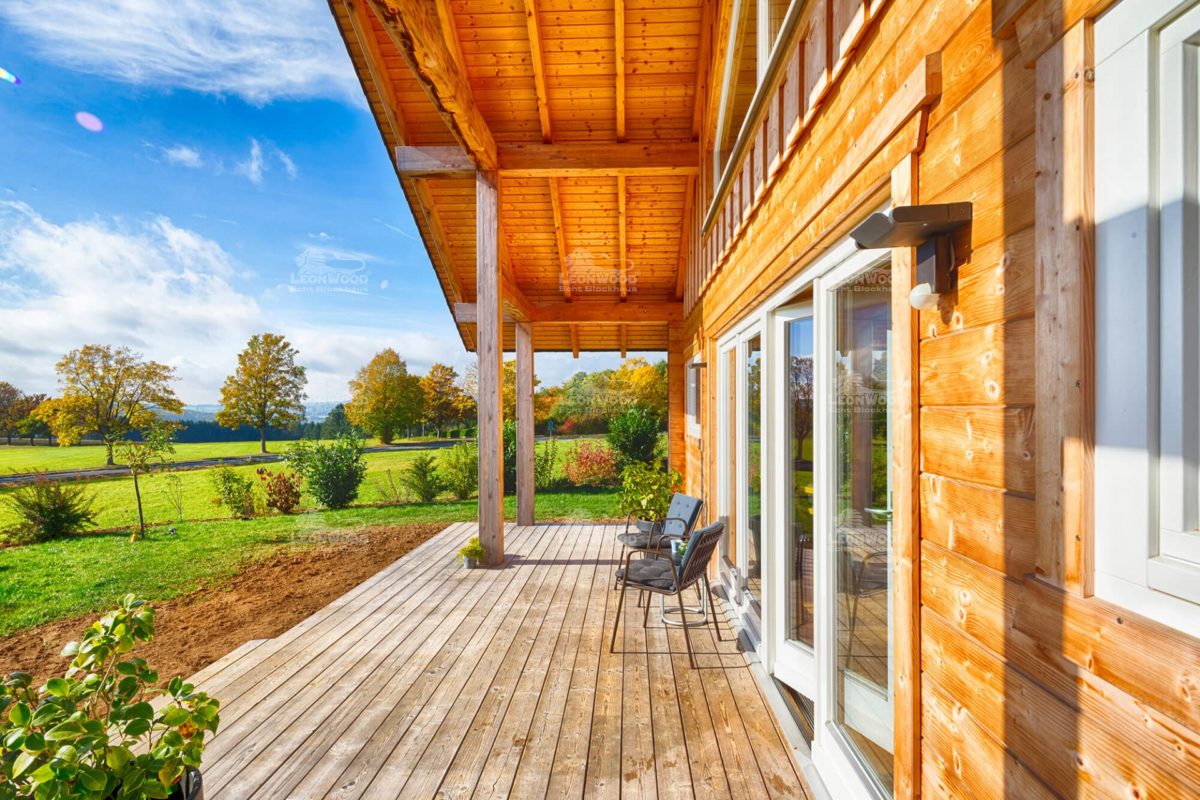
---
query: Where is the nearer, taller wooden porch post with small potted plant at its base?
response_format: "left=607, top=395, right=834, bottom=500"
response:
left=475, top=172, right=504, bottom=566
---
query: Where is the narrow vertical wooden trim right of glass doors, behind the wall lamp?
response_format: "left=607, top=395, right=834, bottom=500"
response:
left=889, top=155, right=922, bottom=800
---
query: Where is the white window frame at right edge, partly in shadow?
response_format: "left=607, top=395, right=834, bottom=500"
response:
left=1094, top=0, right=1200, bottom=636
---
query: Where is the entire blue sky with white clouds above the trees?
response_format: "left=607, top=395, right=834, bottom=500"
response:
left=0, top=0, right=633, bottom=403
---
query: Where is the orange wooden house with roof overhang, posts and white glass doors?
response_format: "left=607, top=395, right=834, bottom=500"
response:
left=331, top=0, right=1200, bottom=800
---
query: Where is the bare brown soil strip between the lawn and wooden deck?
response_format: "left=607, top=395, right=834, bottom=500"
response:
left=0, top=523, right=446, bottom=682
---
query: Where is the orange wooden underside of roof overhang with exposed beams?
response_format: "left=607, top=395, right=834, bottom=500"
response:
left=330, top=0, right=710, bottom=354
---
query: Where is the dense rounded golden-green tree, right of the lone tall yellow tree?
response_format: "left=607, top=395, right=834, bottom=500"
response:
left=346, top=348, right=425, bottom=444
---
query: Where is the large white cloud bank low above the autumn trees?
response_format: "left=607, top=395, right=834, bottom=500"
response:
left=0, top=201, right=461, bottom=403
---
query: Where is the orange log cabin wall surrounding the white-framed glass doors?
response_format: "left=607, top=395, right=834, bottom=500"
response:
left=684, top=0, right=1200, bottom=800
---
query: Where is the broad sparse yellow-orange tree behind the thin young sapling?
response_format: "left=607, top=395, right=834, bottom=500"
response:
left=34, top=344, right=184, bottom=467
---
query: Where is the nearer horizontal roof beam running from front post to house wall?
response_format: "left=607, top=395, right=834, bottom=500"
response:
left=497, top=142, right=700, bottom=178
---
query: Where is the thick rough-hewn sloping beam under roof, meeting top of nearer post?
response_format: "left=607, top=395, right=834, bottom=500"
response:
left=371, top=0, right=498, bottom=169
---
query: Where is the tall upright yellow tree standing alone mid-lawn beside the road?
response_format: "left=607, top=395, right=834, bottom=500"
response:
left=217, top=333, right=307, bottom=452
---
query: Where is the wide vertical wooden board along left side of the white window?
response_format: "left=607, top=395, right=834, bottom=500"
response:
left=1033, top=19, right=1096, bottom=597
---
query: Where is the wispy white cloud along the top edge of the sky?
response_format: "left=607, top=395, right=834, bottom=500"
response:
left=0, top=0, right=365, bottom=106
